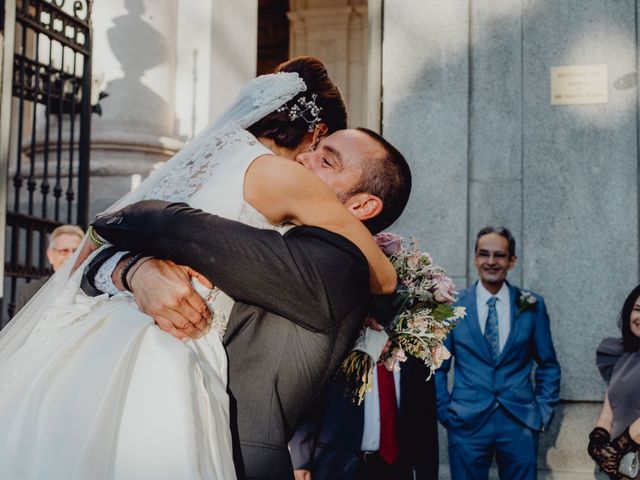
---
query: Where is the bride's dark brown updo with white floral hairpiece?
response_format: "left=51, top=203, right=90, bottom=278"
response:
left=247, top=57, right=347, bottom=148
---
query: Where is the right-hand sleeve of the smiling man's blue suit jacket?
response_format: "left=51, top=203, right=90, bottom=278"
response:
left=534, top=297, right=560, bottom=427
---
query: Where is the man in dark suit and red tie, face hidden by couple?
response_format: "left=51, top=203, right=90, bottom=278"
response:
left=289, top=357, right=438, bottom=480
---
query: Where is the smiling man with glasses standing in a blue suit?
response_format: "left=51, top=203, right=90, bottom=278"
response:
left=436, top=227, right=560, bottom=480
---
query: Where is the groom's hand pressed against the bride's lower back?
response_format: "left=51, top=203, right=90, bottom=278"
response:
left=129, top=259, right=213, bottom=339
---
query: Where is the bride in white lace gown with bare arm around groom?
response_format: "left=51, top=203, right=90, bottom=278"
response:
left=0, top=59, right=406, bottom=479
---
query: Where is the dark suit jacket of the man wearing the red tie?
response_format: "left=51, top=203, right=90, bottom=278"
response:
left=289, top=357, right=438, bottom=480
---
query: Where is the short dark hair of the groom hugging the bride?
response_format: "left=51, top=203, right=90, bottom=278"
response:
left=344, top=127, right=411, bottom=233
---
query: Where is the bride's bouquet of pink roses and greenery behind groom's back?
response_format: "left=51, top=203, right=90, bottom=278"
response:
left=337, top=232, right=466, bottom=405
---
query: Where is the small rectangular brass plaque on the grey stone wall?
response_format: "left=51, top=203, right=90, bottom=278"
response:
left=551, top=65, right=609, bottom=105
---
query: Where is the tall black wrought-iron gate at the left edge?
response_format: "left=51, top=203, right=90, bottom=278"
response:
left=0, top=0, right=92, bottom=323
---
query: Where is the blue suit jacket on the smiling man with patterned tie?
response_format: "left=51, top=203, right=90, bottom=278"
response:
left=436, top=282, right=560, bottom=433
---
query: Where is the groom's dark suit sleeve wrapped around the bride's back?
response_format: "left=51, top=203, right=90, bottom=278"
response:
left=94, top=200, right=369, bottom=331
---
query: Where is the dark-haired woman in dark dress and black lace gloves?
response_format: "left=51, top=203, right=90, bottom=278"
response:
left=588, top=285, right=640, bottom=479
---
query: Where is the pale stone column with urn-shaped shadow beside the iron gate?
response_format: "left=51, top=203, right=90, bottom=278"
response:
left=91, top=0, right=182, bottom=214
